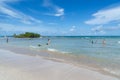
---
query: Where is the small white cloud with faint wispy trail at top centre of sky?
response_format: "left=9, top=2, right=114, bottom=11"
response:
left=43, top=0, right=64, bottom=17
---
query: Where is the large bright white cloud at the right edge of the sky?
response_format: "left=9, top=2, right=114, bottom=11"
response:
left=85, top=6, right=120, bottom=25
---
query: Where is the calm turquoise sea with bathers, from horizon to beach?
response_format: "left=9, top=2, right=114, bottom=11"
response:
left=0, top=36, right=120, bottom=77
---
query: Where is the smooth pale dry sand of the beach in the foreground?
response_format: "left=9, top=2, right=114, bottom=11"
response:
left=0, top=49, right=120, bottom=80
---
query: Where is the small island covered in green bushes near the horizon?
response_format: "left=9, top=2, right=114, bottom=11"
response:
left=13, top=32, right=41, bottom=38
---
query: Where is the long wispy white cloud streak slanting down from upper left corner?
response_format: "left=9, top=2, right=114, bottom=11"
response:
left=0, top=0, right=42, bottom=24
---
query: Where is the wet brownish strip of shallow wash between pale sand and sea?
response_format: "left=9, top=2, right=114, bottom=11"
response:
left=0, top=45, right=120, bottom=78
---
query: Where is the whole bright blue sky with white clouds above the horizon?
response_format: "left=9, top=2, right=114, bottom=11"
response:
left=0, top=0, right=120, bottom=36
